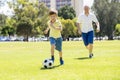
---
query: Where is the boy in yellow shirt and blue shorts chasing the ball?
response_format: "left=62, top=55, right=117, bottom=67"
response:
left=44, top=9, right=64, bottom=65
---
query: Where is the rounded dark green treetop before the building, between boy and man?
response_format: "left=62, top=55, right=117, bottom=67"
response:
left=58, top=5, right=76, bottom=19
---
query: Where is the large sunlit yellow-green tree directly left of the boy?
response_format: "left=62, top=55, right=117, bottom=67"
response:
left=9, top=0, right=48, bottom=41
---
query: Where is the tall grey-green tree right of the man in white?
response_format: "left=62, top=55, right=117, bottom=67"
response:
left=93, top=0, right=120, bottom=40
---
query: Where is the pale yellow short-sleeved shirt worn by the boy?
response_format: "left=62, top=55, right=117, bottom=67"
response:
left=48, top=20, right=62, bottom=38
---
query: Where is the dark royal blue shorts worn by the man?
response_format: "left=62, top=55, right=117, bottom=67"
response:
left=82, top=31, right=94, bottom=46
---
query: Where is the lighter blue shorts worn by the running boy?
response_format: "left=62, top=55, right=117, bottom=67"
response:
left=50, top=37, right=62, bottom=52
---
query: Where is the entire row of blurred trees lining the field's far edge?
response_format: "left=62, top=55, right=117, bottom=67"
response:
left=0, top=0, right=120, bottom=41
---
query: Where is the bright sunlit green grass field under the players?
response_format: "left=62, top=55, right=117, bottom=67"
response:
left=0, top=41, right=120, bottom=80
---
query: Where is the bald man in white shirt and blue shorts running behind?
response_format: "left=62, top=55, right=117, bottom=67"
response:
left=77, top=6, right=100, bottom=58
